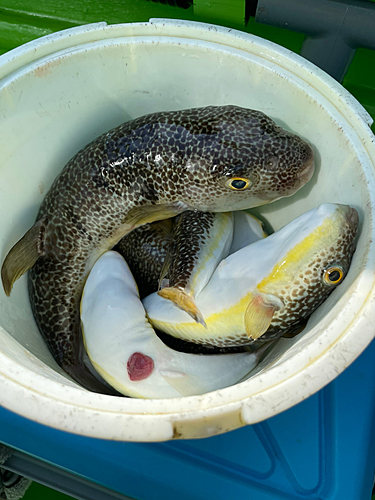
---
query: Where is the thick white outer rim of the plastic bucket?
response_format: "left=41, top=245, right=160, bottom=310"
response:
left=0, top=19, right=375, bottom=441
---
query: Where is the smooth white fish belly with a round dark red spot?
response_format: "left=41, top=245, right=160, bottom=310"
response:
left=81, top=251, right=274, bottom=398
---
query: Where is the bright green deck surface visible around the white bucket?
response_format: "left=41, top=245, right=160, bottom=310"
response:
left=0, top=0, right=375, bottom=500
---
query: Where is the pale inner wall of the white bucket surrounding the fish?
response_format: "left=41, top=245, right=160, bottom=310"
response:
left=0, top=23, right=372, bottom=436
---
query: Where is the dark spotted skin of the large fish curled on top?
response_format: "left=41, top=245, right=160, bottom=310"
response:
left=25, top=106, right=313, bottom=390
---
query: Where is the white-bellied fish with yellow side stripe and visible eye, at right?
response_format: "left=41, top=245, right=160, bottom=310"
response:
left=143, top=204, right=358, bottom=347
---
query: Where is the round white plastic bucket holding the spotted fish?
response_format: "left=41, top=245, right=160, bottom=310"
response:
left=0, top=20, right=375, bottom=441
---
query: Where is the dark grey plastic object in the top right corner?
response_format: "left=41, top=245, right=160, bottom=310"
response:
left=255, top=0, right=375, bottom=82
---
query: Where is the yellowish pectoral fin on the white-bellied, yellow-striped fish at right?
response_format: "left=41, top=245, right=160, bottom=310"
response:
left=244, top=293, right=284, bottom=340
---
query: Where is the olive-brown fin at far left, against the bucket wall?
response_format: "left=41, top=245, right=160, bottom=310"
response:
left=1, top=218, right=46, bottom=297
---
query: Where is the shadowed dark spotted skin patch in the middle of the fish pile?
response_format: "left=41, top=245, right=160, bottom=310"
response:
left=113, top=218, right=176, bottom=299
